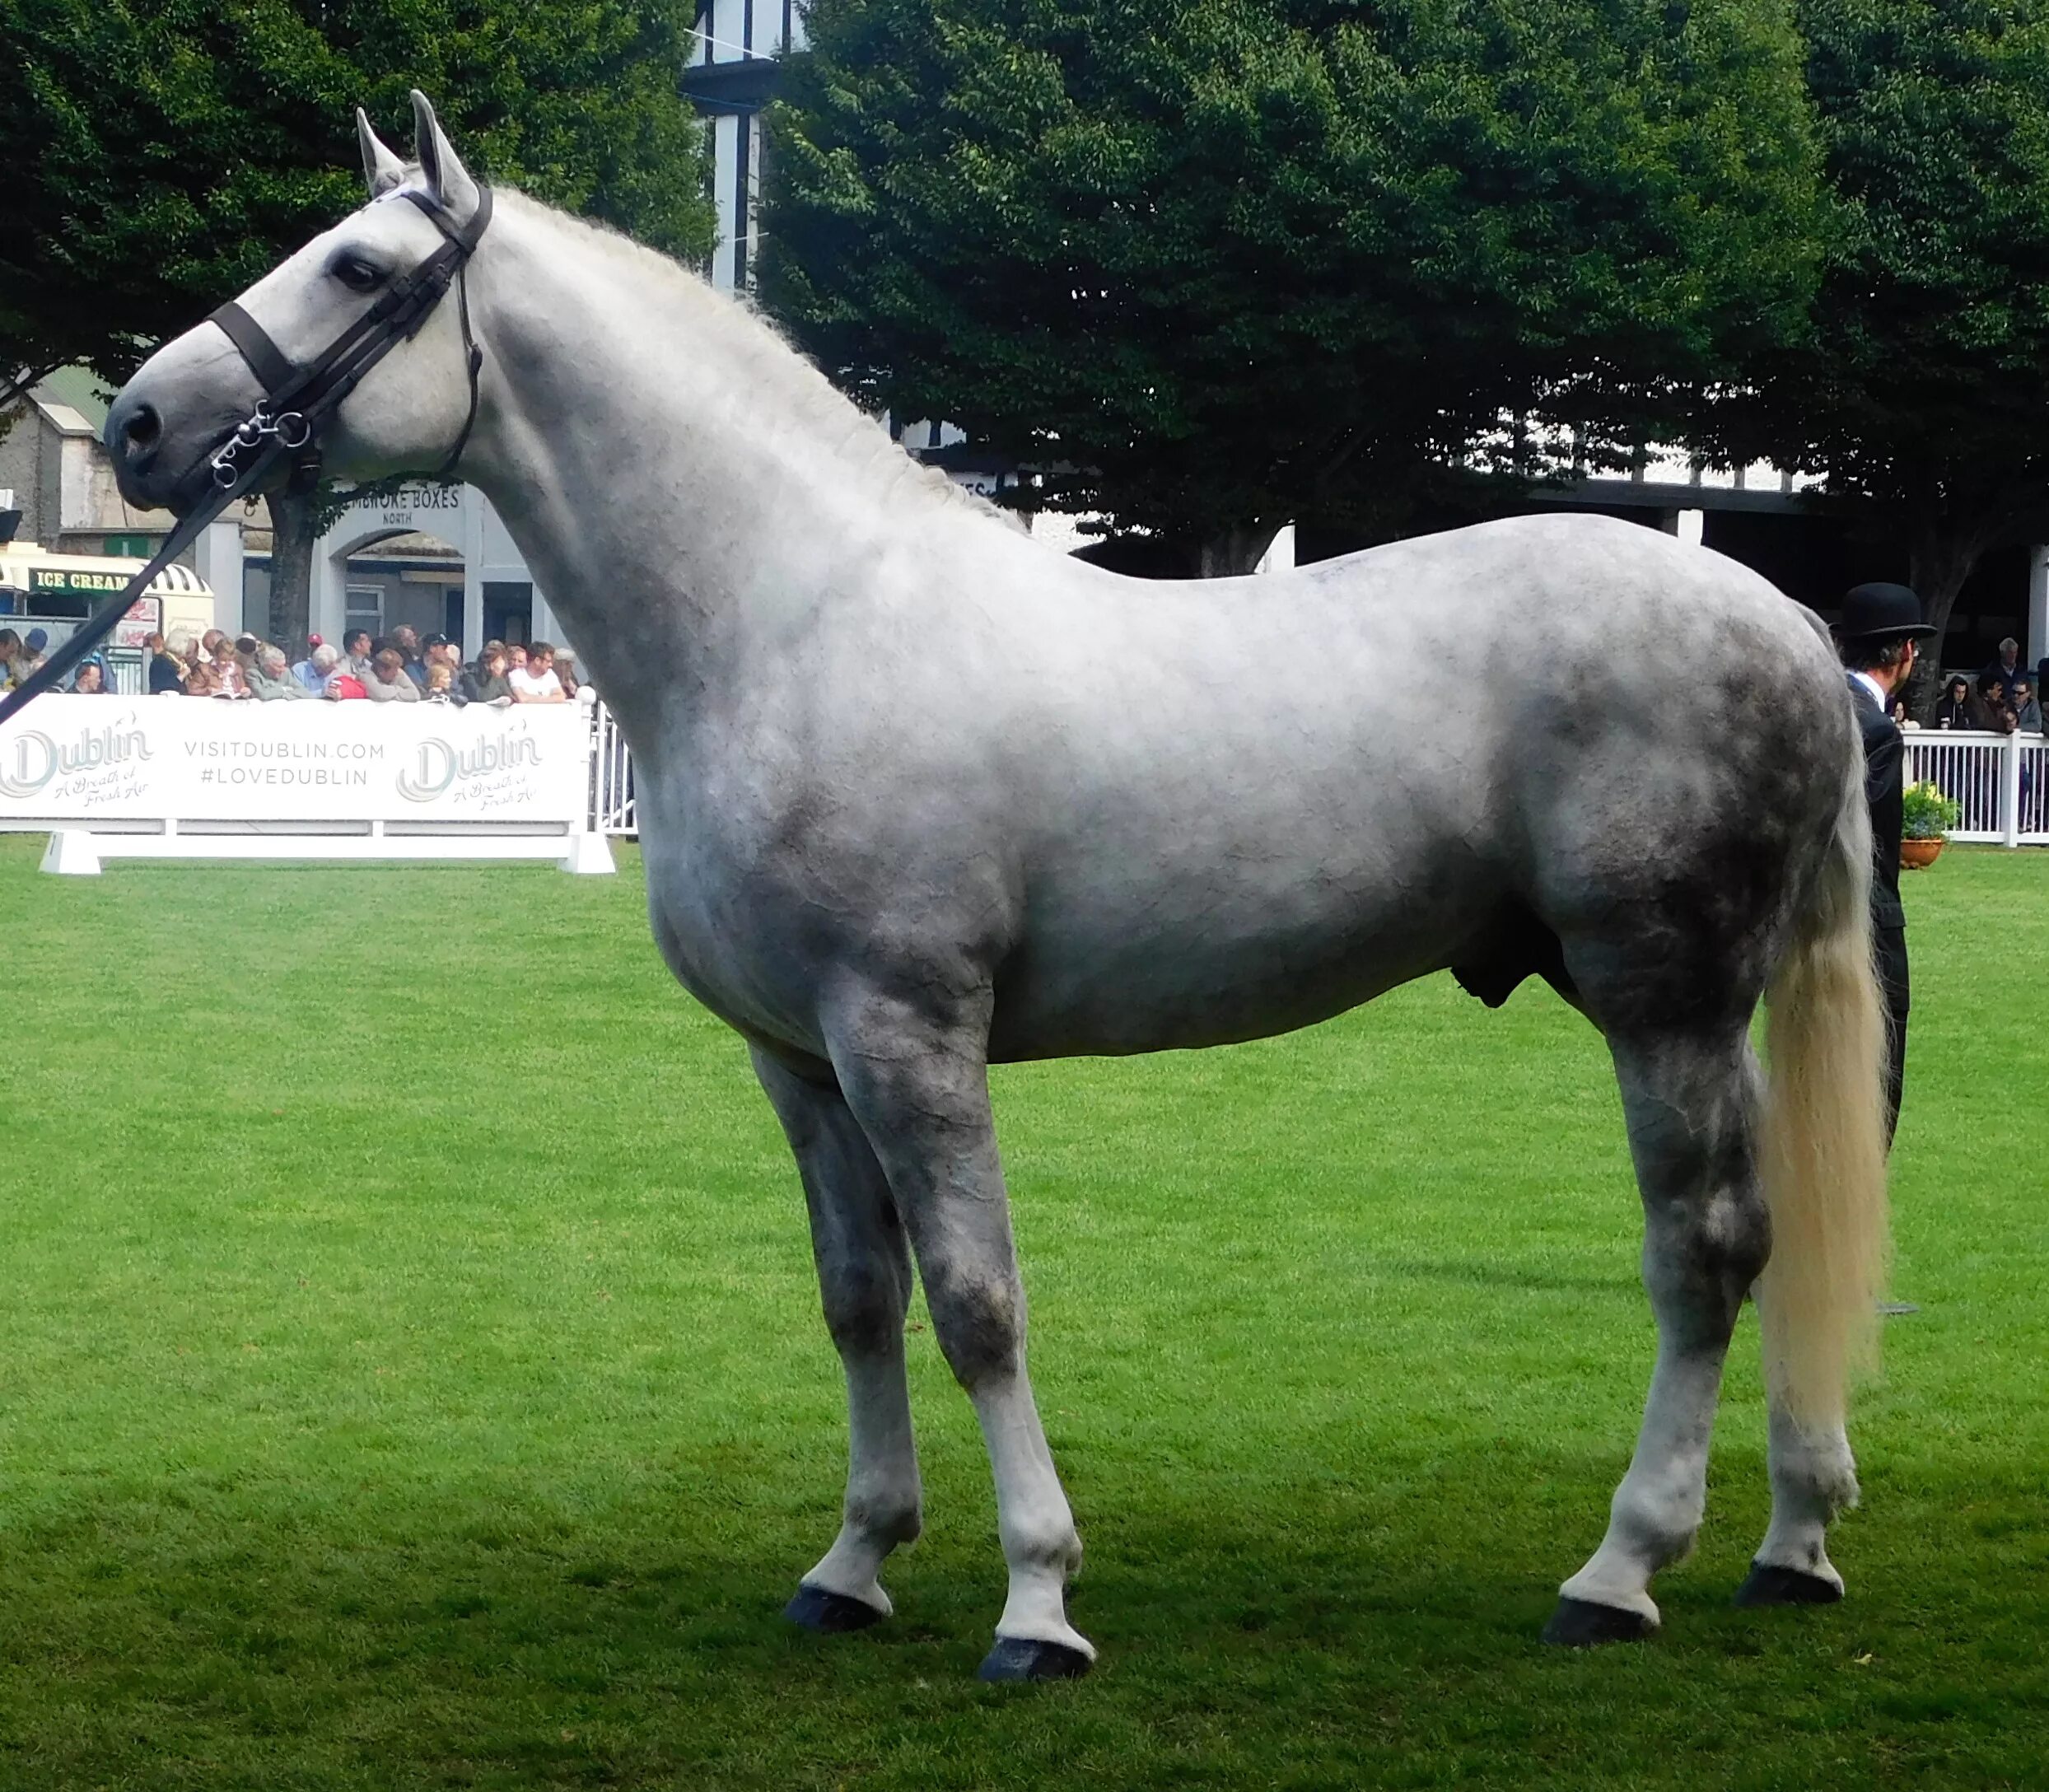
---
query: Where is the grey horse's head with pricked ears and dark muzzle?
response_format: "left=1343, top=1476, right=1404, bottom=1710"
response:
left=106, top=92, right=483, bottom=514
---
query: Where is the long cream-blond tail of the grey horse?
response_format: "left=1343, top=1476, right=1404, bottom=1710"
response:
left=1758, top=731, right=1887, bottom=1435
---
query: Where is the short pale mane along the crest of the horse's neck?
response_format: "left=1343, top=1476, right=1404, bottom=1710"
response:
left=494, top=186, right=1023, bottom=529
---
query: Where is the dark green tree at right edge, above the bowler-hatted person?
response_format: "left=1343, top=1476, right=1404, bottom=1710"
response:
left=1699, top=0, right=2049, bottom=712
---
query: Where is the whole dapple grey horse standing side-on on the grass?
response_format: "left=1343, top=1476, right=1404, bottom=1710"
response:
left=106, top=96, right=1885, bottom=1678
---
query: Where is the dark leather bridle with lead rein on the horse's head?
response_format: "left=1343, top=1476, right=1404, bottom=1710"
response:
left=0, top=182, right=492, bottom=723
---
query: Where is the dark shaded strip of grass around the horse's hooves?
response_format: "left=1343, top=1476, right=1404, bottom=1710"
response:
left=16, top=1444, right=2049, bottom=1788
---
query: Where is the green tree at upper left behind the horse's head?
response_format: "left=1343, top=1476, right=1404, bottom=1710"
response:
left=0, top=0, right=713, bottom=641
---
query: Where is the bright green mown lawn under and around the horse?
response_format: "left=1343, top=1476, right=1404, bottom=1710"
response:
left=0, top=836, right=2049, bottom=1792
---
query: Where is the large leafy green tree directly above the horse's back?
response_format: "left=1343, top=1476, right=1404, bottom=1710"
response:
left=763, top=0, right=1818, bottom=572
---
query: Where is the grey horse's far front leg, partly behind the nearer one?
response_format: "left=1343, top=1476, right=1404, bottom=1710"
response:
left=754, top=1048, right=920, bottom=1631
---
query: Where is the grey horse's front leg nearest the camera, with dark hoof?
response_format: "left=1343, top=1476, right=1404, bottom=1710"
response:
left=830, top=997, right=1096, bottom=1679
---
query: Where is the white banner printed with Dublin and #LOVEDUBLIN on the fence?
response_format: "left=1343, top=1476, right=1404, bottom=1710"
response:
left=0, top=694, right=590, bottom=828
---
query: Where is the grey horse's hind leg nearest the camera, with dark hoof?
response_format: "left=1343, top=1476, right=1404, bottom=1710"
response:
left=1545, top=1022, right=1771, bottom=1645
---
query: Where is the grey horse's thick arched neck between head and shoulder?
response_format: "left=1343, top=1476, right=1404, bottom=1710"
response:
left=465, top=203, right=983, bottom=729
